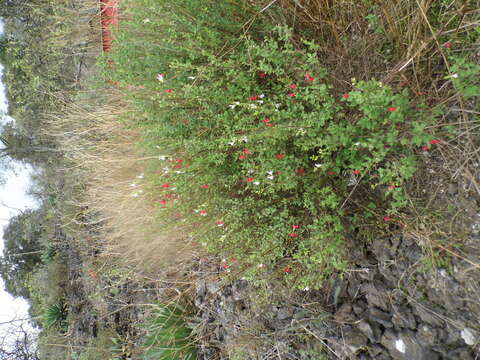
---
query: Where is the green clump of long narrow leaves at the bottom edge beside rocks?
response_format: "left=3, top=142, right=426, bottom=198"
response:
left=142, top=305, right=196, bottom=360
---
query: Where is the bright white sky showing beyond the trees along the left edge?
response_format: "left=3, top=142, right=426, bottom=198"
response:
left=0, top=19, right=36, bottom=331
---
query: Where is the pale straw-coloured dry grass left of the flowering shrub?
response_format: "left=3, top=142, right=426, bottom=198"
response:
left=44, top=90, right=195, bottom=270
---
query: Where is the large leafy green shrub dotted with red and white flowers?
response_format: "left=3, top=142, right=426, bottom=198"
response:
left=103, top=2, right=438, bottom=288
